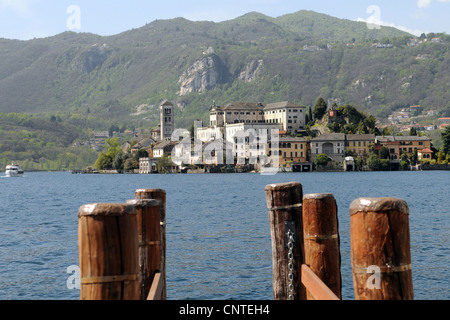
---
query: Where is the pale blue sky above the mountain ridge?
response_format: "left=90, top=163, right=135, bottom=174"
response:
left=0, top=0, right=450, bottom=40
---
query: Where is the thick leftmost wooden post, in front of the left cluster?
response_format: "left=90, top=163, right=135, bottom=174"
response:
left=78, top=204, right=139, bottom=300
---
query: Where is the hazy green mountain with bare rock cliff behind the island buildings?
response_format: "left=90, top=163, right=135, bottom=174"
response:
left=0, top=11, right=450, bottom=127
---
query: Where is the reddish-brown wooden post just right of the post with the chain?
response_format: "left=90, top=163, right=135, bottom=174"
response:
left=303, top=194, right=342, bottom=300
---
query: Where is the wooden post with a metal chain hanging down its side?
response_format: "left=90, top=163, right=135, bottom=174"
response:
left=265, top=182, right=306, bottom=300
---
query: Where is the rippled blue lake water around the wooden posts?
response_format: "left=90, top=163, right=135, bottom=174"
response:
left=0, top=171, right=450, bottom=300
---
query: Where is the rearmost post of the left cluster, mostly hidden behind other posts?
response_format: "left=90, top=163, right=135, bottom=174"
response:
left=135, top=189, right=167, bottom=300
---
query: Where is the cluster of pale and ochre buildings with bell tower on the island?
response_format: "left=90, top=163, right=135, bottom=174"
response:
left=85, top=100, right=448, bottom=174
